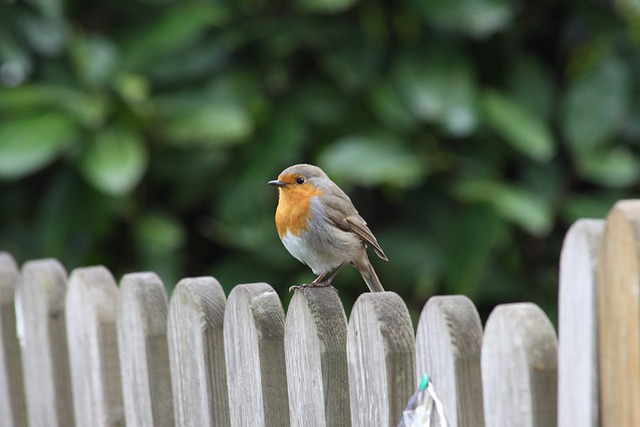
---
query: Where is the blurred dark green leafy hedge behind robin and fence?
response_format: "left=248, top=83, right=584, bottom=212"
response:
left=0, top=0, right=640, bottom=318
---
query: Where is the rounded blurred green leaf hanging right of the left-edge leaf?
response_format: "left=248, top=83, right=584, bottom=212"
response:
left=80, top=127, right=148, bottom=196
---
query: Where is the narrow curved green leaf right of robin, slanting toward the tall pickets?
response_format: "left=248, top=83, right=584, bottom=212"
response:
left=455, top=180, right=553, bottom=236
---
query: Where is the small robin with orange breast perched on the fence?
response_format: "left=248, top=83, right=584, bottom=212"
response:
left=269, top=164, right=388, bottom=292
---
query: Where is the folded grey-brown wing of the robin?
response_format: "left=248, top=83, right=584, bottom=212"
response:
left=325, top=189, right=389, bottom=261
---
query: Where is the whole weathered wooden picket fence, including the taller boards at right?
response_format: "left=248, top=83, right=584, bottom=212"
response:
left=0, top=201, right=640, bottom=427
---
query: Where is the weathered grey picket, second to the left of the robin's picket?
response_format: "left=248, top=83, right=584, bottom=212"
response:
left=169, top=277, right=229, bottom=427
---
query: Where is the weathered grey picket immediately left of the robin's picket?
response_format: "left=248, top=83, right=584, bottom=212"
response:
left=224, top=283, right=289, bottom=426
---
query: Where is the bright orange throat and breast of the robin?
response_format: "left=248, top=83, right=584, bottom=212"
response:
left=276, top=185, right=323, bottom=239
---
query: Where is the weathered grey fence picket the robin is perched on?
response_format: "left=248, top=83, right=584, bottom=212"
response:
left=284, top=288, right=351, bottom=427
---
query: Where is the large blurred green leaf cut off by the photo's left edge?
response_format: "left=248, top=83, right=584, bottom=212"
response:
left=0, top=112, right=78, bottom=179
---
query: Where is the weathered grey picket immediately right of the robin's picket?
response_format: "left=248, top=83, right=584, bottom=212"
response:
left=347, top=292, right=416, bottom=426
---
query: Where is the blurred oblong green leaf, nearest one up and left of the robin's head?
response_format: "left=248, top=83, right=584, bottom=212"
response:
left=166, top=102, right=253, bottom=145
